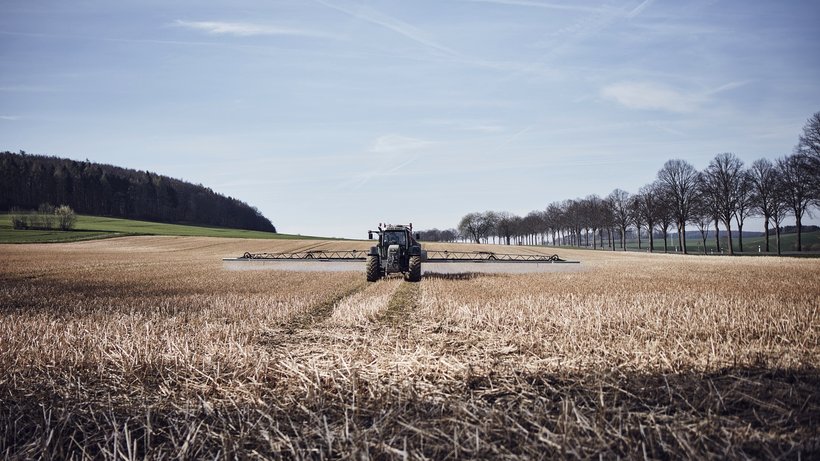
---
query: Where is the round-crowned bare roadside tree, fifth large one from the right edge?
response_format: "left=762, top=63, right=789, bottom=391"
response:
left=658, top=159, right=699, bottom=254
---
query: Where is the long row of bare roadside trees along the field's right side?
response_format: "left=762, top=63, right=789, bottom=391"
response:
left=422, top=112, right=820, bottom=254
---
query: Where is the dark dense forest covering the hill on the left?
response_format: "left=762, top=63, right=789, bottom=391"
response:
left=0, top=151, right=276, bottom=232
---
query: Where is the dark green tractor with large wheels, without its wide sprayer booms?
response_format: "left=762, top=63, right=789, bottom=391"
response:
left=367, top=224, right=426, bottom=282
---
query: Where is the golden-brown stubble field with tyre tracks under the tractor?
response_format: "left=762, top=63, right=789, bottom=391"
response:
left=0, top=236, right=820, bottom=459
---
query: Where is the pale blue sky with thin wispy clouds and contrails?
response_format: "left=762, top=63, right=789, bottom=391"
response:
left=0, top=0, right=820, bottom=238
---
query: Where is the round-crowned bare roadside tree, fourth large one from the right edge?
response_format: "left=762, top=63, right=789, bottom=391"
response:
left=700, top=152, right=744, bottom=255
